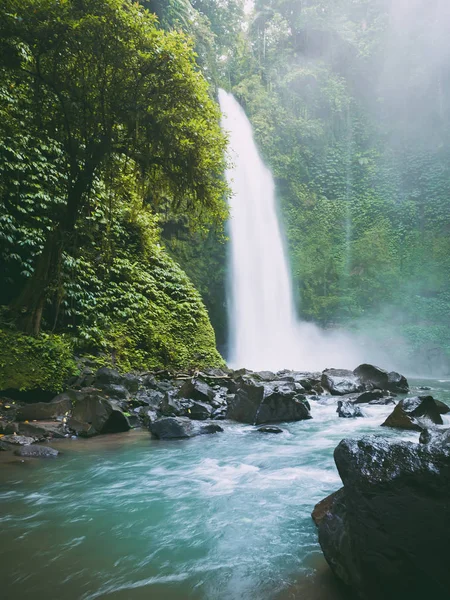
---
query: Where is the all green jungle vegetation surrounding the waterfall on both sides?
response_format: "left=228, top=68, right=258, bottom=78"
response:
left=0, top=0, right=450, bottom=387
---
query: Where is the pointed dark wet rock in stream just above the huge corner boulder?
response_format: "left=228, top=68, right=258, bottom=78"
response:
left=382, top=396, right=443, bottom=431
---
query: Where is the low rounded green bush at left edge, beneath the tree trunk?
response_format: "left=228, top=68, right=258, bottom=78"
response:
left=0, top=329, right=77, bottom=393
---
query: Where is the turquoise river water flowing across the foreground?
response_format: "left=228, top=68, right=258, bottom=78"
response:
left=0, top=381, right=450, bottom=600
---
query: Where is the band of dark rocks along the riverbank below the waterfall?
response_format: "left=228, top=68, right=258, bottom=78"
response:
left=0, top=365, right=408, bottom=456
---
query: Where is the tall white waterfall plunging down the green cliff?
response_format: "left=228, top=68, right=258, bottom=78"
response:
left=219, top=90, right=359, bottom=371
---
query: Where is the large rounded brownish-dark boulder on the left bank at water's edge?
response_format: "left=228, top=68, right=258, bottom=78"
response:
left=67, top=389, right=130, bottom=437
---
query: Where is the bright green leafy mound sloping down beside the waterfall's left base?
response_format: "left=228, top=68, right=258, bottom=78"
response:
left=71, top=244, right=224, bottom=371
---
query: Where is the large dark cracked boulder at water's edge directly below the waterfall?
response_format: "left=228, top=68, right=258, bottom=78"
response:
left=227, top=381, right=311, bottom=425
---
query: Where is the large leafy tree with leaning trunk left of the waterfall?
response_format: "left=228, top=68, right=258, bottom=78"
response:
left=0, top=0, right=226, bottom=334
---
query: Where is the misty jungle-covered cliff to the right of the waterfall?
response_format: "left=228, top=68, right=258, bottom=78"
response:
left=157, top=0, right=450, bottom=373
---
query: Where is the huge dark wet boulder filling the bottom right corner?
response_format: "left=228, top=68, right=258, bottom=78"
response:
left=316, top=436, right=450, bottom=600
